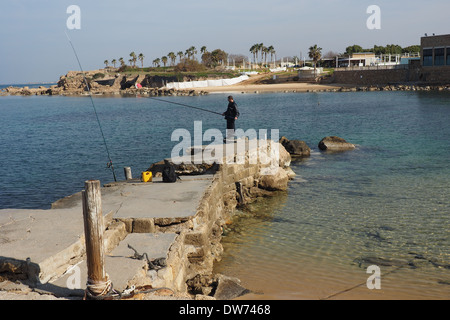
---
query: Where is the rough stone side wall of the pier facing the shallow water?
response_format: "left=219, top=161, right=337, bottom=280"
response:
left=161, top=141, right=292, bottom=292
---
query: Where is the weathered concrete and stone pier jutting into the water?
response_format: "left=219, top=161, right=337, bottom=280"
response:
left=0, top=141, right=291, bottom=299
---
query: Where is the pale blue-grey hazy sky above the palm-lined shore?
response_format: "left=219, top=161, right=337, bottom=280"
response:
left=0, top=0, right=450, bottom=84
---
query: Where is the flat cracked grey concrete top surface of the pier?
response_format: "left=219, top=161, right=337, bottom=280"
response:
left=0, top=175, right=212, bottom=299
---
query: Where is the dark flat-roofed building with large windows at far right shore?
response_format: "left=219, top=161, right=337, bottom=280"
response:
left=420, top=34, right=450, bottom=68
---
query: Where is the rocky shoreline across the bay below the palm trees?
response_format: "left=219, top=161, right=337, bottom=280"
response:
left=0, top=69, right=450, bottom=97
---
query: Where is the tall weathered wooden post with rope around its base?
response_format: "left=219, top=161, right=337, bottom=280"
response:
left=82, top=180, right=110, bottom=296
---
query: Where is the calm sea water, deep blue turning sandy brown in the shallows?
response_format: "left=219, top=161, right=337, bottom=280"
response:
left=0, top=86, right=450, bottom=300
